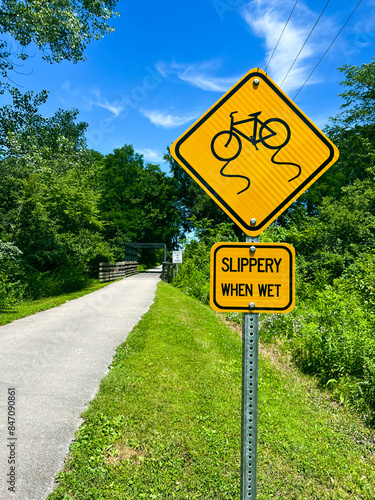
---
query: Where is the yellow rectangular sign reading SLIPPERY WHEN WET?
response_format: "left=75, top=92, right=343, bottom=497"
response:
left=210, top=242, right=295, bottom=313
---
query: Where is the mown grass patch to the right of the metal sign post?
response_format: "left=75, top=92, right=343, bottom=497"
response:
left=259, top=347, right=375, bottom=500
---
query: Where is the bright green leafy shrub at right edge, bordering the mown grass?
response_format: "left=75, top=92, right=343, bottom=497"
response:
left=261, top=282, right=375, bottom=420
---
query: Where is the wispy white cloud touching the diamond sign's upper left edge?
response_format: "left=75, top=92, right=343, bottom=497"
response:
left=156, top=59, right=239, bottom=92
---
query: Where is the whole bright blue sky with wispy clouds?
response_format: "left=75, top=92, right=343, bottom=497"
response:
left=1, top=0, right=375, bottom=171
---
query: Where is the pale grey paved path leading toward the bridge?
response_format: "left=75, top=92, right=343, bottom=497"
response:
left=0, top=269, right=160, bottom=500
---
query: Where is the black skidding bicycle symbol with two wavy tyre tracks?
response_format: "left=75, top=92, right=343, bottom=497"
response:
left=211, top=111, right=302, bottom=194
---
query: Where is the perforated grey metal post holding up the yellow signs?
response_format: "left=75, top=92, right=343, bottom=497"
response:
left=241, top=236, right=259, bottom=500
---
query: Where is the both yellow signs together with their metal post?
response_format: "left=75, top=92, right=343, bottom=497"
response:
left=171, top=68, right=339, bottom=500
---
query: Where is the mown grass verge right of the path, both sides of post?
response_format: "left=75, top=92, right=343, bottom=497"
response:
left=49, top=283, right=375, bottom=500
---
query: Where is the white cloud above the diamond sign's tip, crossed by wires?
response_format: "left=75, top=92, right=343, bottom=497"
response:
left=241, top=0, right=335, bottom=92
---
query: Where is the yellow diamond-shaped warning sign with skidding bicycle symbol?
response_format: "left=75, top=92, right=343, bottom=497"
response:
left=171, top=69, right=339, bottom=236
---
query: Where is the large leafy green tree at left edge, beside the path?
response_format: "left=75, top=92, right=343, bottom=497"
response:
left=0, top=89, right=110, bottom=297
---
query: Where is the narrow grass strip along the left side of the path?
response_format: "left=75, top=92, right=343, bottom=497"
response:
left=0, top=280, right=110, bottom=326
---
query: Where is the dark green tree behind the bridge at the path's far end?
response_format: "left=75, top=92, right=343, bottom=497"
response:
left=100, top=145, right=181, bottom=259
